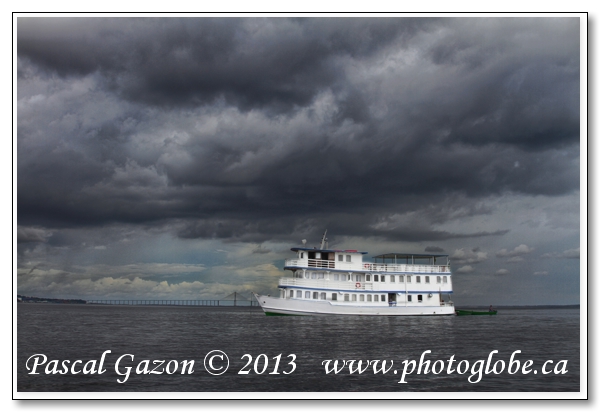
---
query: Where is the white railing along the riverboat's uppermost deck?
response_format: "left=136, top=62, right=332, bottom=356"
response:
left=285, top=259, right=450, bottom=273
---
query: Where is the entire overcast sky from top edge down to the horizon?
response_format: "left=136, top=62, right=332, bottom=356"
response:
left=16, top=17, right=580, bottom=305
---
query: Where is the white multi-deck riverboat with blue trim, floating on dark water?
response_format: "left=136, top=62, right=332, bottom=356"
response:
left=255, top=236, right=455, bottom=316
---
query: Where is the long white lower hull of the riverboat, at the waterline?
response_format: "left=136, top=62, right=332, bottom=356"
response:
left=255, top=295, right=455, bottom=316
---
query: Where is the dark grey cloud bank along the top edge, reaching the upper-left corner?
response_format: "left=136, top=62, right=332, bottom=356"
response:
left=18, top=18, right=430, bottom=109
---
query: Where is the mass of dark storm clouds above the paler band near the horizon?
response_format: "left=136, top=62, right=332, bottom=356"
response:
left=17, top=18, right=579, bottom=242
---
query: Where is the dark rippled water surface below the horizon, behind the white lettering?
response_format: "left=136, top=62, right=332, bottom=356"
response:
left=17, top=304, right=580, bottom=392
